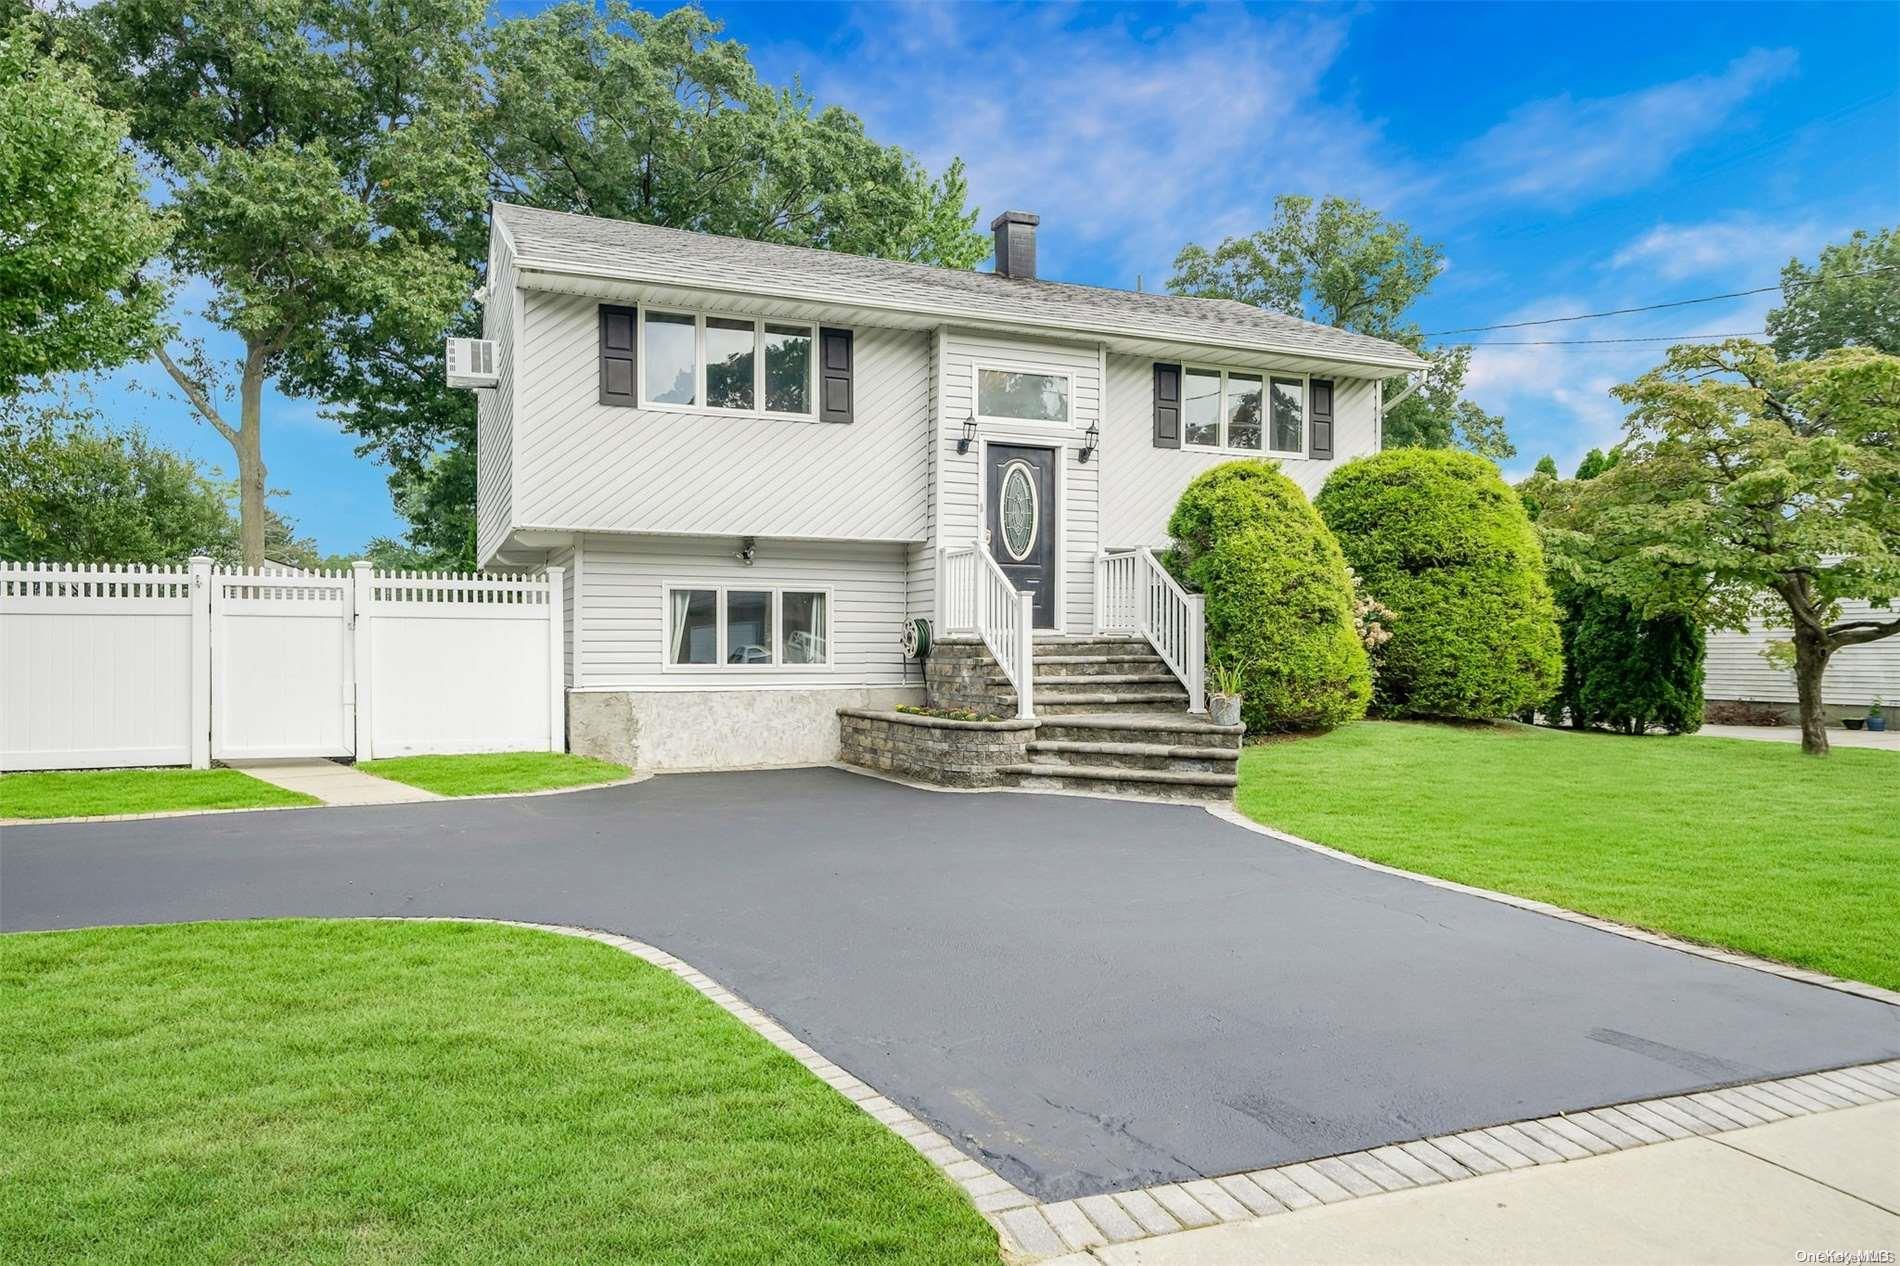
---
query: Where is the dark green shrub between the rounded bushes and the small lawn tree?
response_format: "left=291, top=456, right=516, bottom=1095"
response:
left=1545, top=585, right=1704, bottom=734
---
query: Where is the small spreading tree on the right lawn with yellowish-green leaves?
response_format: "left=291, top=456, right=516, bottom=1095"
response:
left=1573, top=338, right=1900, bottom=755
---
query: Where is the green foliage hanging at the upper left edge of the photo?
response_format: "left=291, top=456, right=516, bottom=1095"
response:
left=0, top=17, right=165, bottom=395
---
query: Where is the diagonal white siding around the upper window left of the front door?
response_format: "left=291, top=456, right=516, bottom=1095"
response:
left=504, top=291, right=931, bottom=542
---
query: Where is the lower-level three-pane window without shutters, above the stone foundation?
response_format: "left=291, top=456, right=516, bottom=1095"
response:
left=667, top=587, right=830, bottom=669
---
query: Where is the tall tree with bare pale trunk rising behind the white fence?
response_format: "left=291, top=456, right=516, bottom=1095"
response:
left=67, top=0, right=485, bottom=565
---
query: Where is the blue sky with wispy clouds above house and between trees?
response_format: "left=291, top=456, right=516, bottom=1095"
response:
left=99, top=0, right=1900, bottom=551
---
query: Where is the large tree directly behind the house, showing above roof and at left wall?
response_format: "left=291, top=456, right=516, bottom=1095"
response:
left=298, top=0, right=988, bottom=566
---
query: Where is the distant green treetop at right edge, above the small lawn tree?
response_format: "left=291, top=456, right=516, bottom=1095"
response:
left=1767, top=228, right=1900, bottom=359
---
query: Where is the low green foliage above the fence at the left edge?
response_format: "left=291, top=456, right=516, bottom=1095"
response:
left=0, top=409, right=236, bottom=563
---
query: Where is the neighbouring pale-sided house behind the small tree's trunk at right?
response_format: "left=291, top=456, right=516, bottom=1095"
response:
left=1702, top=603, right=1900, bottom=722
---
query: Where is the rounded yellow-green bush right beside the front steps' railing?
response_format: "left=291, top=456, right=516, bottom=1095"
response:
left=1169, top=460, right=1372, bottom=732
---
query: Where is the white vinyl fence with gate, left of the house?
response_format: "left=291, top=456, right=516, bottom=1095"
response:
left=0, top=559, right=566, bottom=770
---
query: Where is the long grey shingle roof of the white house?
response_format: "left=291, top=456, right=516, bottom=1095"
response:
left=494, top=203, right=1425, bottom=369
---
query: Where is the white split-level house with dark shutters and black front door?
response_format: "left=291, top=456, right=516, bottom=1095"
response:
left=477, top=203, right=1423, bottom=770
